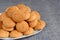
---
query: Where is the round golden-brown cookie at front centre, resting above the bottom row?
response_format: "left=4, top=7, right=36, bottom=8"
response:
left=16, top=21, right=29, bottom=32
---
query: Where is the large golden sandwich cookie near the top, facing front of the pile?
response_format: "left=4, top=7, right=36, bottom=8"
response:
left=12, top=10, right=30, bottom=22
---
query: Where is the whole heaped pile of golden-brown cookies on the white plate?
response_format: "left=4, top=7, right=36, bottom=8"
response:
left=0, top=4, right=46, bottom=38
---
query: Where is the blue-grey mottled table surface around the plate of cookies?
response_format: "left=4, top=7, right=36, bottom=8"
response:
left=0, top=0, right=60, bottom=40
